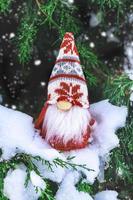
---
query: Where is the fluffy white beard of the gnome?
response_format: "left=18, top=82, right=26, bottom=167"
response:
left=43, top=105, right=91, bottom=144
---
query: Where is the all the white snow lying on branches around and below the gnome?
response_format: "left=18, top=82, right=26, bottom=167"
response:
left=0, top=100, right=127, bottom=200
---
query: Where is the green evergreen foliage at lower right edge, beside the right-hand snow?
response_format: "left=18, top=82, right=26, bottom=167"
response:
left=106, top=122, right=133, bottom=186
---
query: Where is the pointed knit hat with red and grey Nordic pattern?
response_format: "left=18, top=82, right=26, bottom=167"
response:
left=47, top=32, right=89, bottom=108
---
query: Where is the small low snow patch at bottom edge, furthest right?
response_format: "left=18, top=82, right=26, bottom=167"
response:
left=94, top=190, right=118, bottom=200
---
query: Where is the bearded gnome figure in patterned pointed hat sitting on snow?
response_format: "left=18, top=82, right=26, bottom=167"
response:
left=35, top=32, right=95, bottom=151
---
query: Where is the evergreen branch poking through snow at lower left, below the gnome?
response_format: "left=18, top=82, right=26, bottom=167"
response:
left=0, top=153, right=94, bottom=200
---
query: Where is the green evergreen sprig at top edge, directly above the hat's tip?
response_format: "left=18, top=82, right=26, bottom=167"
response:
left=35, top=0, right=80, bottom=37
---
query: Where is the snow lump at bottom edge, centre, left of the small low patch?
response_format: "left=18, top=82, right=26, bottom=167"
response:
left=56, top=172, right=93, bottom=200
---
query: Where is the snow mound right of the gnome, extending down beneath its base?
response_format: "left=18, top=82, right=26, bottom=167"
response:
left=61, top=100, right=127, bottom=184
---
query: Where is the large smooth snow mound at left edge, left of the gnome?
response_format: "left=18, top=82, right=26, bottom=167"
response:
left=0, top=106, right=62, bottom=160
